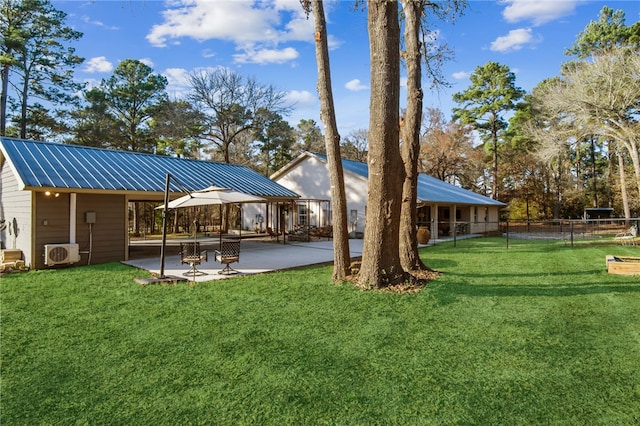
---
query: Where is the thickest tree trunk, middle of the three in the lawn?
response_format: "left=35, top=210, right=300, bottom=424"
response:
left=358, top=0, right=405, bottom=288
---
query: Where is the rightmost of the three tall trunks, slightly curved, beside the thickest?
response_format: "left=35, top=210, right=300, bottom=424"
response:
left=400, top=0, right=427, bottom=271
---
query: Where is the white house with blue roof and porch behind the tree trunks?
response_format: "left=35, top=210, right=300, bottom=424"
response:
left=262, top=152, right=505, bottom=240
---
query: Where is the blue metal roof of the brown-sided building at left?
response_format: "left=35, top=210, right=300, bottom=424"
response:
left=0, top=138, right=299, bottom=198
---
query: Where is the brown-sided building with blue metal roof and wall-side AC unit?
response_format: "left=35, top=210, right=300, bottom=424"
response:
left=0, top=137, right=298, bottom=269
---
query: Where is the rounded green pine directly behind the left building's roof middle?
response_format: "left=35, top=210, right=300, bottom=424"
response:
left=100, top=59, right=167, bottom=152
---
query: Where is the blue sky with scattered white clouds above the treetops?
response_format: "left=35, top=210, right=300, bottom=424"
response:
left=53, top=0, right=640, bottom=137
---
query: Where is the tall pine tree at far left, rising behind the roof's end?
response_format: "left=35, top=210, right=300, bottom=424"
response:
left=0, top=0, right=84, bottom=138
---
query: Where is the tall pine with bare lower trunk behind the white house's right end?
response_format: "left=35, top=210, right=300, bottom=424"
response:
left=453, top=62, right=524, bottom=199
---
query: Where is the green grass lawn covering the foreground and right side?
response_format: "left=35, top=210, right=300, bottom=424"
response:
left=0, top=238, right=640, bottom=425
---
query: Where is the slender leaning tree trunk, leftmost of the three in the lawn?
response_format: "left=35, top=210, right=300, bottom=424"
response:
left=311, top=0, right=351, bottom=281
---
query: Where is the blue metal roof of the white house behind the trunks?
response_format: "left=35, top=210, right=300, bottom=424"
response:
left=310, top=153, right=505, bottom=206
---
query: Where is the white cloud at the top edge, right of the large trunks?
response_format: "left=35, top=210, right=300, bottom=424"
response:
left=500, top=0, right=580, bottom=25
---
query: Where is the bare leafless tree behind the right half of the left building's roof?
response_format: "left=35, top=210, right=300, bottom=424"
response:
left=189, top=68, right=290, bottom=163
